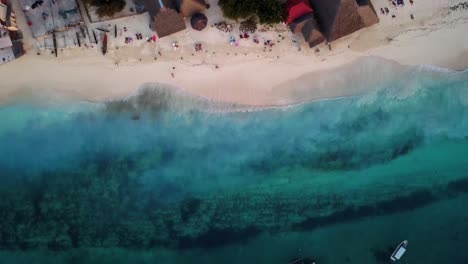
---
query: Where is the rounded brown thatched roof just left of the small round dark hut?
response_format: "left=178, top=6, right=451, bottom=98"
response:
left=153, top=7, right=186, bottom=38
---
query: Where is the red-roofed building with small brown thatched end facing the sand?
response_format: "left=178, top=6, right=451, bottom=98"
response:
left=286, top=0, right=325, bottom=47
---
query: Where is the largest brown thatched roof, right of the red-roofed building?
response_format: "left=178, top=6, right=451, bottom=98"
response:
left=310, top=0, right=378, bottom=41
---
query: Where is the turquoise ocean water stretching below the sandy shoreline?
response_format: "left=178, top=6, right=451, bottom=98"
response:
left=0, top=60, right=468, bottom=264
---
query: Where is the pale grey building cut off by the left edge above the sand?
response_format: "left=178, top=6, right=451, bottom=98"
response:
left=0, top=0, right=24, bottom=64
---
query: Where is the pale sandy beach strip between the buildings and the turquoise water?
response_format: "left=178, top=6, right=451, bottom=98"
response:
left=0, top=0, right=468, bottom=105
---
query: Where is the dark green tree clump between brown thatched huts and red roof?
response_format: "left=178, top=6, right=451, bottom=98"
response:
left=219, top=0, right=284, bottom=24
